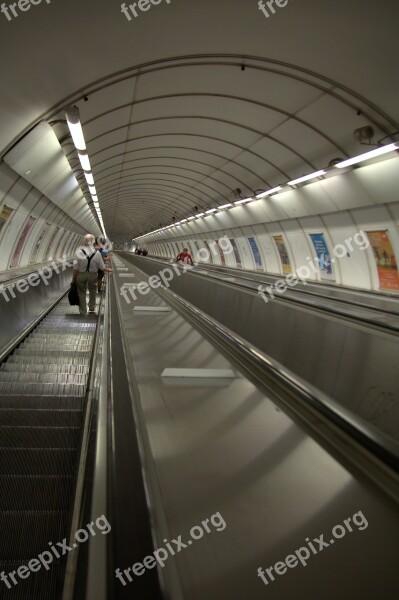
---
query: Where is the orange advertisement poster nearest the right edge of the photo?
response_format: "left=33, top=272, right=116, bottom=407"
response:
left=366, top=231, right=399, bottom=290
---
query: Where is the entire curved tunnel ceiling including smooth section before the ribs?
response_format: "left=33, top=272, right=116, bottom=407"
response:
left=0, top=0, right=399, bottom=238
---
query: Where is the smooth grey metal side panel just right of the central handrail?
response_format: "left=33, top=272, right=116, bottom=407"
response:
left=123, top=255, right=399, bottom=439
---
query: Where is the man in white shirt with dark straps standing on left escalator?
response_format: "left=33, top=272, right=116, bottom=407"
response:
left=72, top=233, right=112, bottom=315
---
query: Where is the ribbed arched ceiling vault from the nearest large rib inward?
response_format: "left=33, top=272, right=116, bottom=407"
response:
left=1, top=40, right=399, bottom=237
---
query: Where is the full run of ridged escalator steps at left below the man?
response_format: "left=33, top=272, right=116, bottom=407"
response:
left=0, top=298, right=97, bottom=600
